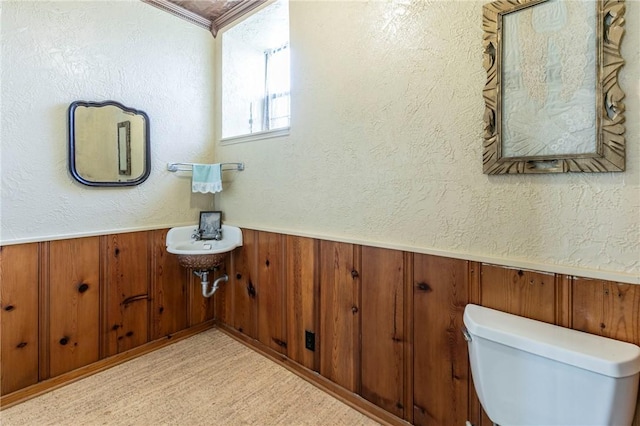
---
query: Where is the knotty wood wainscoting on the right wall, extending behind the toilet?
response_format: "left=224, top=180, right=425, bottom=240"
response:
left=217, top=230, right=640, bottom=426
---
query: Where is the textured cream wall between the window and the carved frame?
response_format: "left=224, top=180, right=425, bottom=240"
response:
left=216, top=0, right=640, bottom=283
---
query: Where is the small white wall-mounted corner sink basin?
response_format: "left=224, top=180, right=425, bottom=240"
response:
left=166, top=225, right=242, bottom=269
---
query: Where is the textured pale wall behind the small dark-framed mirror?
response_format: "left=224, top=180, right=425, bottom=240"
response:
left=0, top=0, right=215, bottom=244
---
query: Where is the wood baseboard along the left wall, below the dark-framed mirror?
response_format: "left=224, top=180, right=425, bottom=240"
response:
left=0, top=320, right=215, bottom=411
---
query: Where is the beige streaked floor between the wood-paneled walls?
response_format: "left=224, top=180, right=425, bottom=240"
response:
left=0, top=328, right=378, bottom=426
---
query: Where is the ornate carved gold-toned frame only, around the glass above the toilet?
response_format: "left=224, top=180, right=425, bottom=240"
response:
left=482, top=0, right=625, bottom=174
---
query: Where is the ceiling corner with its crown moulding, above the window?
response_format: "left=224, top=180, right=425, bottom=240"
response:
left=142, top=0, right=266, bottom=37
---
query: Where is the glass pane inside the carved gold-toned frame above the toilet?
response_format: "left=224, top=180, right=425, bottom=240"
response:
left=502, top=0, right=596, bottom=157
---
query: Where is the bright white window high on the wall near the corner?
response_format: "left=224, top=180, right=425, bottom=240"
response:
left=221, top=0, right=291, bottom=140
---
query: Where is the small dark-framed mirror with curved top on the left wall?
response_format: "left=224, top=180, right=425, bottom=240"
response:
left=69, top=101, right=151, bottom=186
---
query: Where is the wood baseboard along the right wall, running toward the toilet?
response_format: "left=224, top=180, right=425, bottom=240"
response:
left=216, top=323, right=410, bottom=426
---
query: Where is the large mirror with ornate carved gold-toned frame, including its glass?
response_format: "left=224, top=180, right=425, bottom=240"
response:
left=482, top=0, right=625, bottom=174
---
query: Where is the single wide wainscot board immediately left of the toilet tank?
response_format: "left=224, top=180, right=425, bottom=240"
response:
left=413, top=255, right=469, bottom=425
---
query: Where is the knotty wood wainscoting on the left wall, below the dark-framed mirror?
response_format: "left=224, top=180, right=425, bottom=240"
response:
left=0, top=230, right=214, bottom=402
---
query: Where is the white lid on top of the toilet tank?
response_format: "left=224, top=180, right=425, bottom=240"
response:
left=464, top=304, right=640, bottom=377
